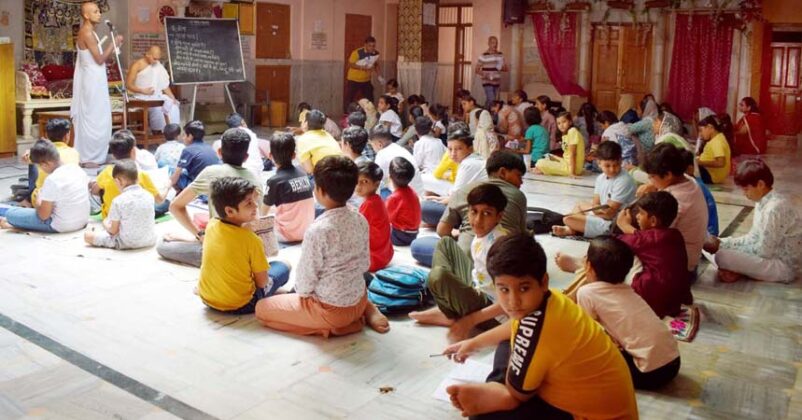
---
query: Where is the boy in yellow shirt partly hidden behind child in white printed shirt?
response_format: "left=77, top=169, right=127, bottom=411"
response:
left=89, top=130, right=169, bottom=219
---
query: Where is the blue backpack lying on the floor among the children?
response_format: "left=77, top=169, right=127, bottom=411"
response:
left=368, top=266, right=432, bottom=314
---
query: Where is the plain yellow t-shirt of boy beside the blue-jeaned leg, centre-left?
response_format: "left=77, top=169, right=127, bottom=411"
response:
left=198, top=218, right=270, bottom=311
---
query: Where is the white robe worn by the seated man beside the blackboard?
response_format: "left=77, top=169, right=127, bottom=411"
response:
left=134, top=62, right=181, bottom=131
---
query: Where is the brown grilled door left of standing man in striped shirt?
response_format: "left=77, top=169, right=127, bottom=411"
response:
left=435, top=4, right=473, bottom=112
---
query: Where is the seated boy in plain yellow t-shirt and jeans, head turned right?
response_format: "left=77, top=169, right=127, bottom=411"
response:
left=198, top=176, right=290, bottom=314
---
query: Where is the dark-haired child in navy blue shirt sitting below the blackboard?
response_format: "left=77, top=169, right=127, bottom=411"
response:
left=171, top=120, right=220, bottom=193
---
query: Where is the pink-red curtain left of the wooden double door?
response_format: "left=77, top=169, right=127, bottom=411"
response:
left=532, top=13, right=588, bottom=97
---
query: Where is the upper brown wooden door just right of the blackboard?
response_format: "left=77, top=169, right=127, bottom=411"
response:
left=256, top=3, right=291, bottom=58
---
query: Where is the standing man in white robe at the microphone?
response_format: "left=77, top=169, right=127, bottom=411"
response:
left=70, top=2, right=123, bottom=167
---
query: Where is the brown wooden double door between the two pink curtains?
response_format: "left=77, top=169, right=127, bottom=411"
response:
left=591, top=24, right=652, bottom=112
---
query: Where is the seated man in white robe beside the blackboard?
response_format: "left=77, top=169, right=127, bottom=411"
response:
left=126, top=45, right=181, bottom=131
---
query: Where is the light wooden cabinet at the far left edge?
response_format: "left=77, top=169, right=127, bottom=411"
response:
left=0, top=44, right=17, bottom=156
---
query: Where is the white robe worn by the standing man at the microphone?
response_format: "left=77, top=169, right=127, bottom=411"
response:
left=70, top=34, right=111, bottom=164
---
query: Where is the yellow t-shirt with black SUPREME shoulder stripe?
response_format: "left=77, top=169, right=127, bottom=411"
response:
left=507, top=290, right=638, bottom=419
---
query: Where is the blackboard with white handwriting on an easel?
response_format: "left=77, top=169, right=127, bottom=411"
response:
left=164, top=17, right=245, bottom=85
